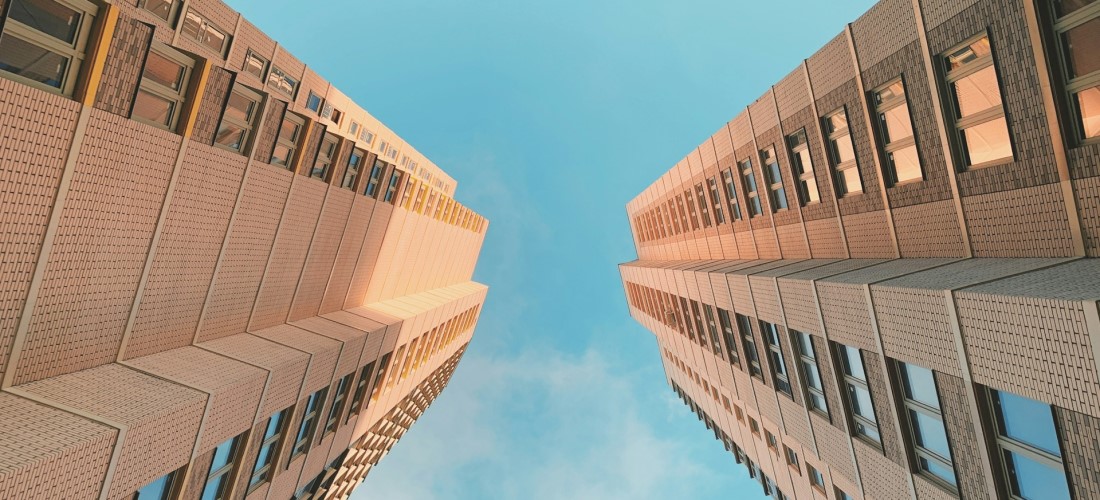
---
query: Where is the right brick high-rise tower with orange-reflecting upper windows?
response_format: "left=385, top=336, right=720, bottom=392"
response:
left=620, top=0, right=1100, bottom=500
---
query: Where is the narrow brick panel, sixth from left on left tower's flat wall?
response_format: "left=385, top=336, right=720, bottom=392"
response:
left=289, top=189, right=355, bottom=321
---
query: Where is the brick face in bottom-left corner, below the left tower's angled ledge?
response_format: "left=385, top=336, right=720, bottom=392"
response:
left=0, top=392, right=118, bottom=499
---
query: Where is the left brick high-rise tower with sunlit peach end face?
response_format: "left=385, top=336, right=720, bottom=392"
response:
left=0, top=0, right=487, bottom=500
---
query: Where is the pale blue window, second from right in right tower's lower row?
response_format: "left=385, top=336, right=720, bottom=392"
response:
left=898, top=363, right=956, bottom=488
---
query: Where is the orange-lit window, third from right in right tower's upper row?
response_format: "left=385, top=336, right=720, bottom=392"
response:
left=873, top=78, right=924, bottom=185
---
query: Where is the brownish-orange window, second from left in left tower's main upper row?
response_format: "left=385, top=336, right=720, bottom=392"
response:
left=131, top=42, right=195, bottom=130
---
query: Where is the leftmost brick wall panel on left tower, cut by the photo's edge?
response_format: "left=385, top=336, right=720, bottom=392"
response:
left=0, top=79, right=78, bottom=382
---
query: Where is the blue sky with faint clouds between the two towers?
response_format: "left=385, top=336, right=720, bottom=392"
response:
left=228, top=0, right=873, bottom=500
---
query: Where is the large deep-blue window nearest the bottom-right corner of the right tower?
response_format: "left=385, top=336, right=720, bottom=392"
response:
left=989, top=390, right=1070, bottom=500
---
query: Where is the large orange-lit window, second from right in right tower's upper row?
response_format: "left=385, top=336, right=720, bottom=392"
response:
left=943, top=35, right=1012, bottom=167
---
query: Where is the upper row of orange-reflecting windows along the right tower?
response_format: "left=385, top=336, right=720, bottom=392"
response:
left=634, top=11, right=1100, bottom=242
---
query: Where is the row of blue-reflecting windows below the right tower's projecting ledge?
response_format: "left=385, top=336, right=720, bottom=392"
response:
left=627, top=282, right=1070, bottom=500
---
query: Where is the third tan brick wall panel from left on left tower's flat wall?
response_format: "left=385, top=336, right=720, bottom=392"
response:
left=125, top=144, right=245, bottom=358
